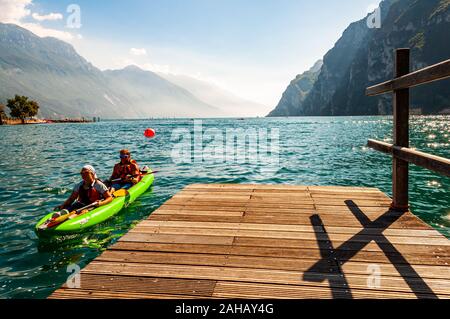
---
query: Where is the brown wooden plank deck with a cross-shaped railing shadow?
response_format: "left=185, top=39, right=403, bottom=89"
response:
left=50, top=184, right=450, bottom=299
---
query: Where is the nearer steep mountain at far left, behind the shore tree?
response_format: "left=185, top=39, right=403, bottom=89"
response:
left=0, top=24, right=120, bottom=117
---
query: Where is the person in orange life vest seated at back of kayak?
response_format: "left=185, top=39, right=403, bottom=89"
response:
left=109, top=150, right=142, bottom=192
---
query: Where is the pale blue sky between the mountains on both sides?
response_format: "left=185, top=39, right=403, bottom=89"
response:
left=0, top=0, right=379, bottom=114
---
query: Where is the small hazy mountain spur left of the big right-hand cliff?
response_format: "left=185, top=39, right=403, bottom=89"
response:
left=269, top=60, right=323, bottom=117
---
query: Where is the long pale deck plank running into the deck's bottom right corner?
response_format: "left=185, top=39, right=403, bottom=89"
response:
left=82, top=261, right=450, bottom=294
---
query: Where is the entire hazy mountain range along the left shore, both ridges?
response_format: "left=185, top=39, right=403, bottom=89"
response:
left=0, top=23, right=224, bottom=118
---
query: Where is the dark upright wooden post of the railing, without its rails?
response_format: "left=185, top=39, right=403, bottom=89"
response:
left=391, top=49, right=410, bottom=211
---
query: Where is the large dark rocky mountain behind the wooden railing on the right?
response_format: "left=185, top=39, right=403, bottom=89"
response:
left=268, top=0, right=450, bottom=116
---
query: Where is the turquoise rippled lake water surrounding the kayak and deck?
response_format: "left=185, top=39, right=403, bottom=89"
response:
left=0, top=116, right=450, bottom=298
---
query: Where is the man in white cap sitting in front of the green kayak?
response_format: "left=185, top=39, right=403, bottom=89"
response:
left=57, top=165, right=113, bottom=211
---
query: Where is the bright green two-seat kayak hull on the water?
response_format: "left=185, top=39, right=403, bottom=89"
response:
left=35, top=173, right=155, bottom=235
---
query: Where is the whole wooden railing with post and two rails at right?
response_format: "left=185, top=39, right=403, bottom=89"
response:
left=366, top=49, right=450, bottom=211
